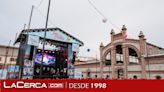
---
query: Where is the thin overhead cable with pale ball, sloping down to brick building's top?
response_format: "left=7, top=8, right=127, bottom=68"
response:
left=88, top=0, right=120, bottom=30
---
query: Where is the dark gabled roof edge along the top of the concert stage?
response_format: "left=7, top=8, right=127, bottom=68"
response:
left=15, top=27, right=84, bottom=46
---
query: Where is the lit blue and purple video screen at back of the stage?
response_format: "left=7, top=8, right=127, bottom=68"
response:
left=35, top=53, right=56, bottom=65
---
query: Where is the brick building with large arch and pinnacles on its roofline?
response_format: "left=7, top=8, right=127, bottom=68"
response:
left=100, top=26, right=164, bottom=79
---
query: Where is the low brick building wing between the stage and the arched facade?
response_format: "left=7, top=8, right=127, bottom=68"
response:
left=75, top=57, right=100, bottom=79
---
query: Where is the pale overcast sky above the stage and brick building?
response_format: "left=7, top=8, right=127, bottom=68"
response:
left=0, top=0, right=164, bottom=57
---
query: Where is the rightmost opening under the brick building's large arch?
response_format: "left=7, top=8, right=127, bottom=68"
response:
left=129, top=48, right=139, bottom=64
